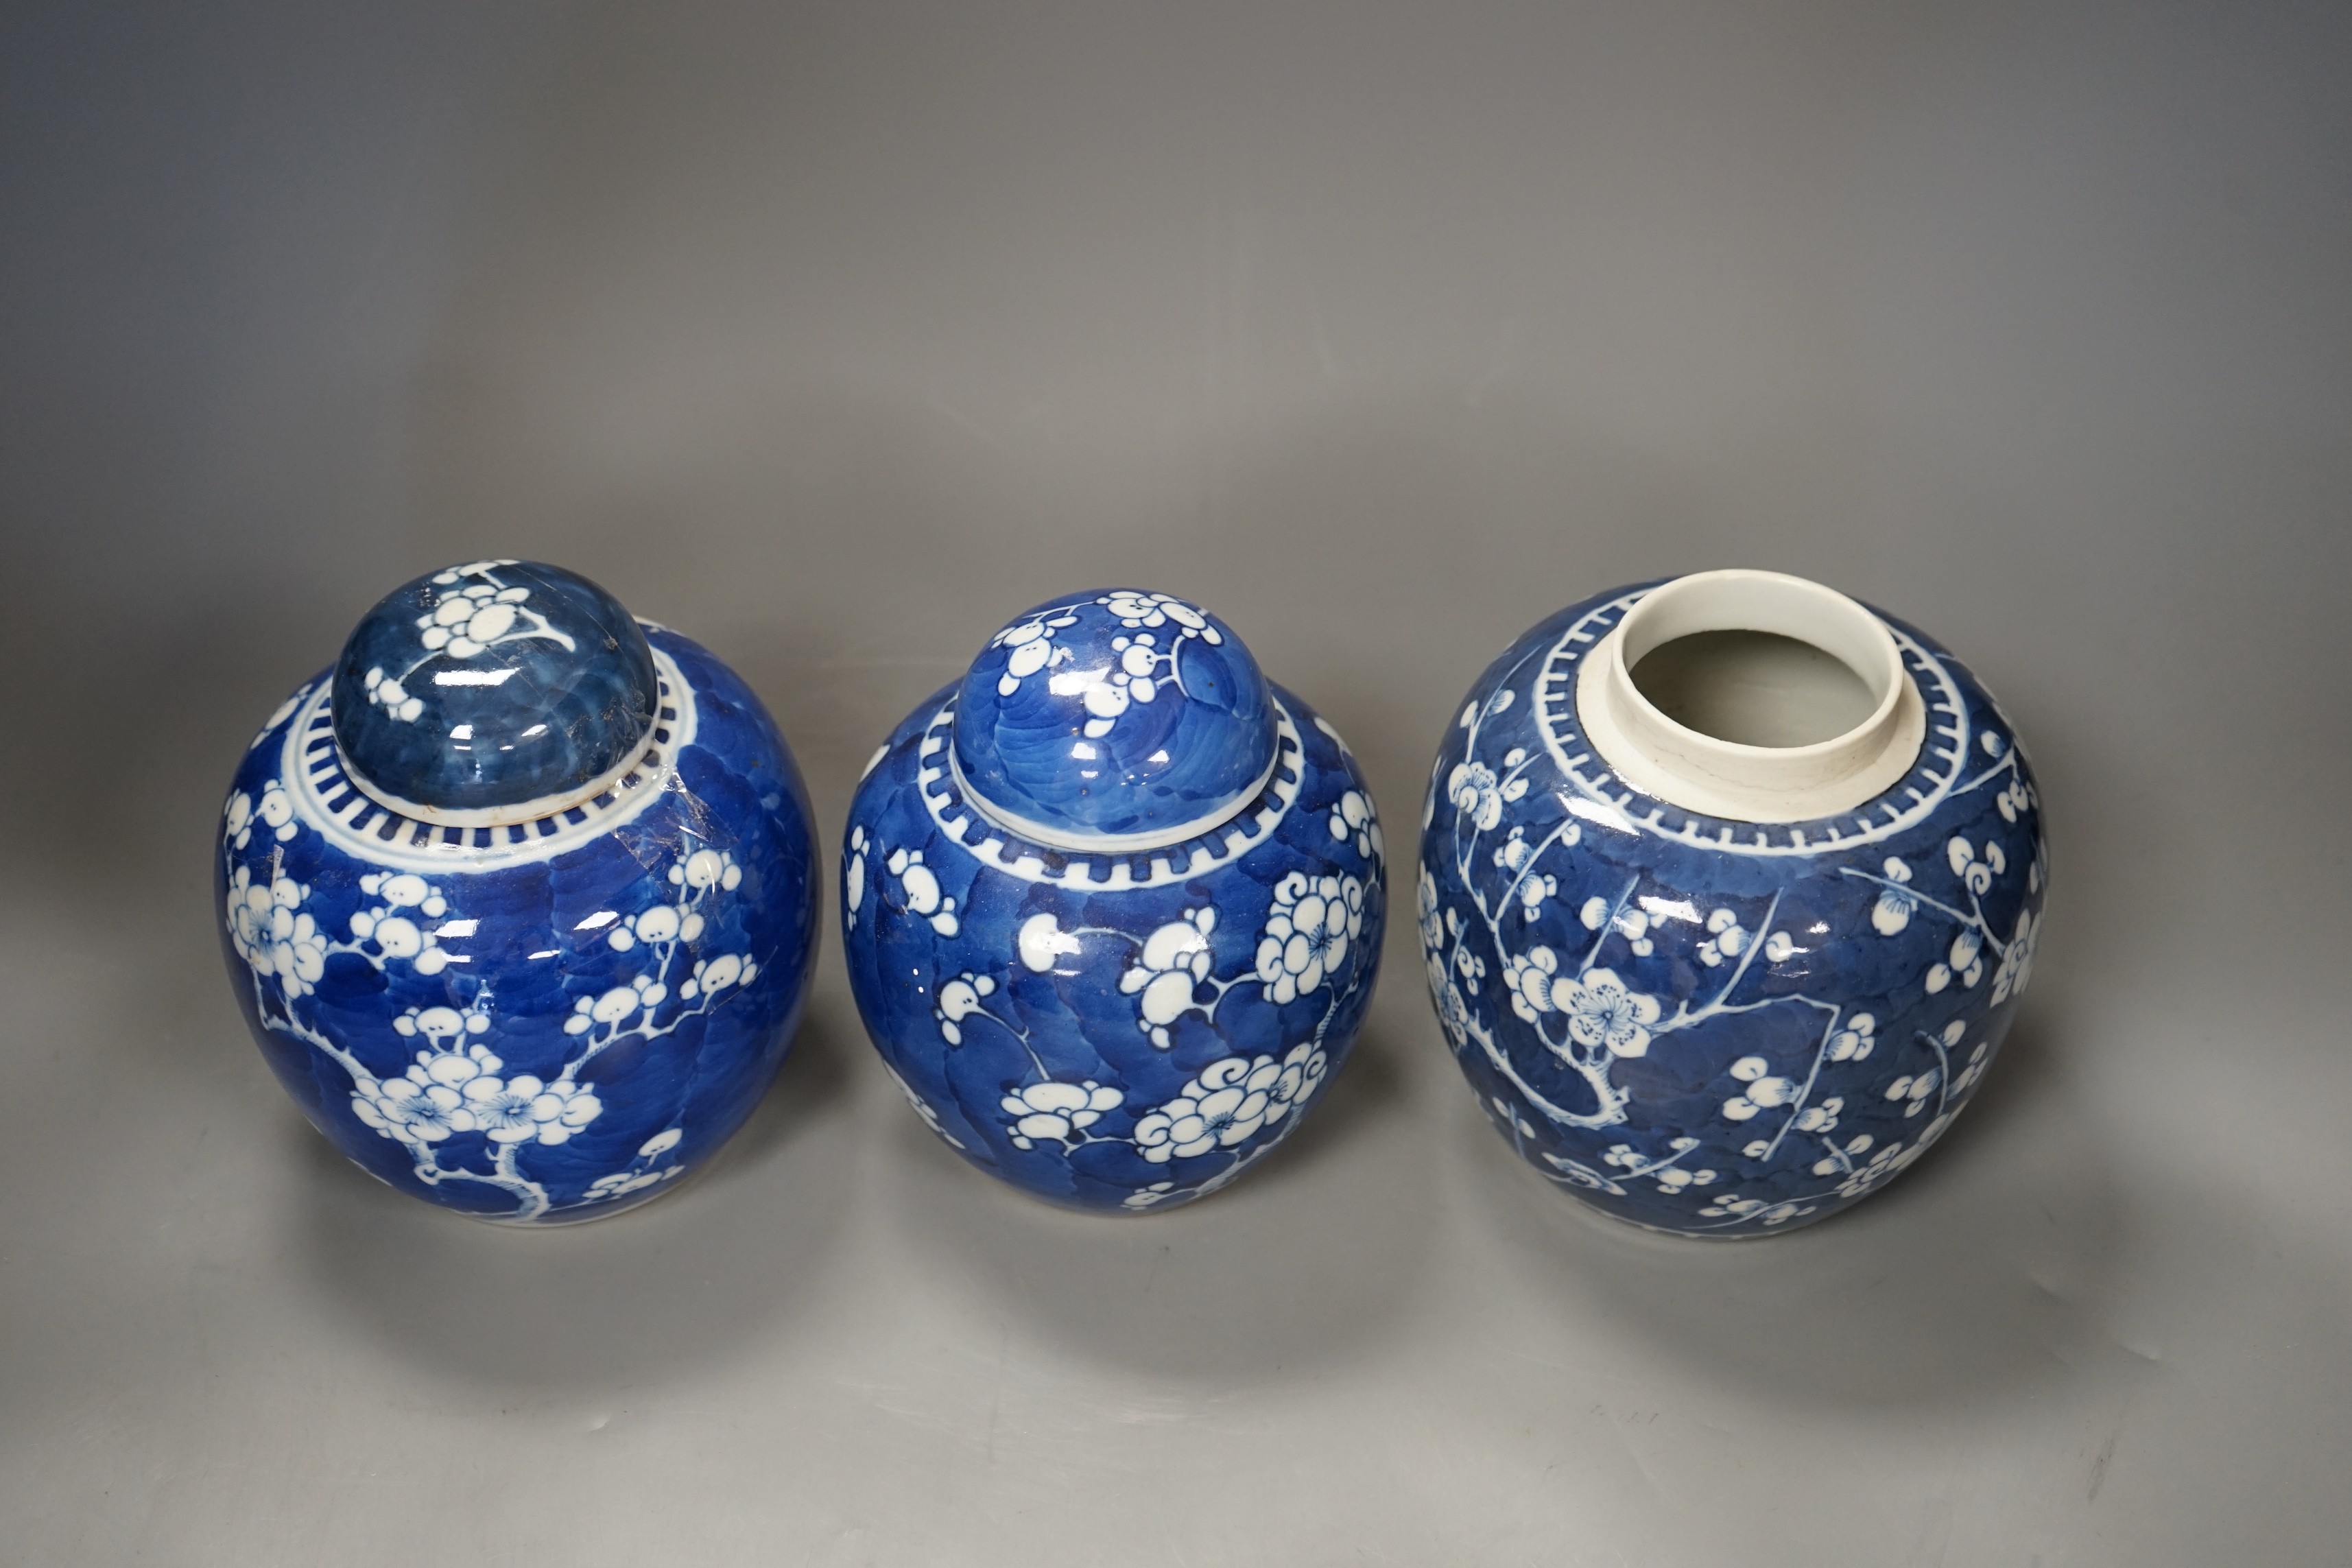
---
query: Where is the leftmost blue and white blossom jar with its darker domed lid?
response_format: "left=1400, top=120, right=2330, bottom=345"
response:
left=219, top=560, right=816, bottom=1225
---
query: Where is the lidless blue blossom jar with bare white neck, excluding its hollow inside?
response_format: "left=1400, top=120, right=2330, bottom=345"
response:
left=1418, top=571, right=2049, bottom=1237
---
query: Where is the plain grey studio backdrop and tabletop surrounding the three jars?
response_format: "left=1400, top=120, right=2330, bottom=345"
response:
left=0, top=5, right=2352, bottom=1568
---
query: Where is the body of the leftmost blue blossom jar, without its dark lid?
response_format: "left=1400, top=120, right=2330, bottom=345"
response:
left=216, top=626, right=816, bottom=1225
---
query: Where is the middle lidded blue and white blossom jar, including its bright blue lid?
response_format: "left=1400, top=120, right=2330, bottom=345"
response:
left=842, top=588, right=1388, bottom=1213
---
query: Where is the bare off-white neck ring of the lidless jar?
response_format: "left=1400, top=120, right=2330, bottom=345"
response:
left=1578, top=569, right=1926, bottom=823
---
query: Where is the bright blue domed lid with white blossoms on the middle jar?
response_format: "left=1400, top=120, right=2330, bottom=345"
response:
left=953, top=588, right=1277, bottom=851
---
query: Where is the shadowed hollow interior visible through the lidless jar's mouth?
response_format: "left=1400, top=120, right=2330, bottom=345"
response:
left=1632, top=630, right=1879, bottom=748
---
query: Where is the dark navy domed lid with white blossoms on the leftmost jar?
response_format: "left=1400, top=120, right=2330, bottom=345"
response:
left=331, top=562, right=661, bottom=827
